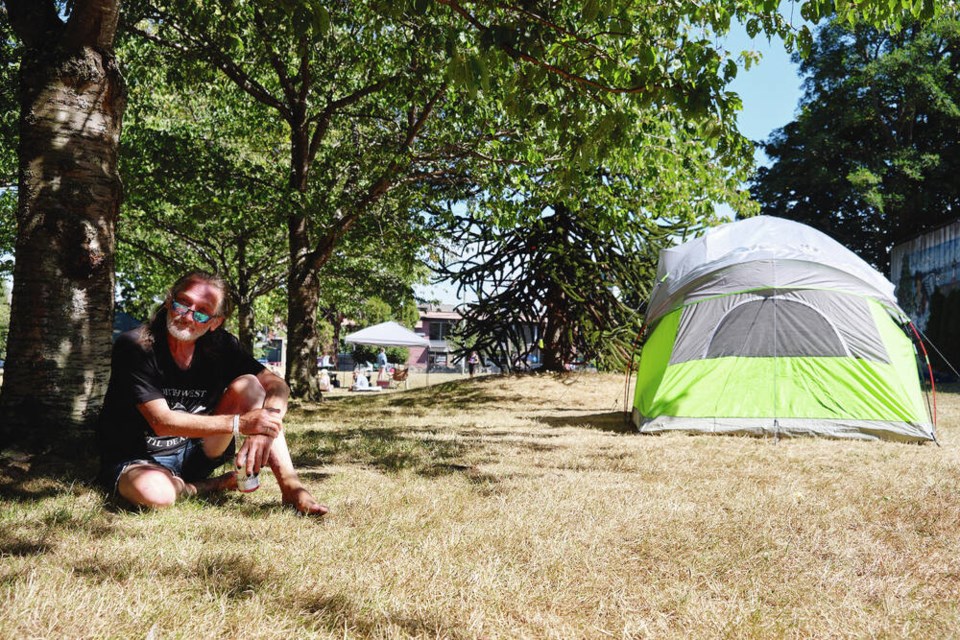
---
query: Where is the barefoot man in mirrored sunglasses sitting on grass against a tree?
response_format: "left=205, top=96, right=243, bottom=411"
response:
left=97, top=271, right=327, bottom=515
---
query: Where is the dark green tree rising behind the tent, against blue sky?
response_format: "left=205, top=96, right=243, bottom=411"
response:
left=751, top=16, right=960, bottom=272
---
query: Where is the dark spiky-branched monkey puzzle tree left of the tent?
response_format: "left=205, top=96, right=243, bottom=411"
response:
left=441, top=203, right=655, bottom=371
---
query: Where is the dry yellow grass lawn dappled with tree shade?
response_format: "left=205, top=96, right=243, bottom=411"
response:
left=0, top=375, right=960, bottom=639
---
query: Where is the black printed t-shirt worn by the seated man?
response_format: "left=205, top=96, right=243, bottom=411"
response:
left=97, top=314, right=264, bottom=467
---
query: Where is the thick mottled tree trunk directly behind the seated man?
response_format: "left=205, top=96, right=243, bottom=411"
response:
left=0, top=47, right=126, bottom=442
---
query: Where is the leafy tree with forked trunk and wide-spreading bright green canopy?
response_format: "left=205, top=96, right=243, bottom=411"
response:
left=116, top=0, right=860, bottom=396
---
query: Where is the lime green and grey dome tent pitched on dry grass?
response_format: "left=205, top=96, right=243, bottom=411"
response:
left=633, top=216, right=934, bottom=442
